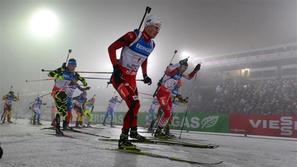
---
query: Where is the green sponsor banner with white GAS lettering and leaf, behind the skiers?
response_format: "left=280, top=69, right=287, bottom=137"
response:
left=93, top=112, right=229, bottom=132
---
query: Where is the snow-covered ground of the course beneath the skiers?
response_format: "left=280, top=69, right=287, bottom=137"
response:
left=0, top=120, right=297, bottom=167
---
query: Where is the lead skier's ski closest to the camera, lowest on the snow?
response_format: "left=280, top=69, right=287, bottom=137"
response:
left=106, top=148, right=224, bottom=165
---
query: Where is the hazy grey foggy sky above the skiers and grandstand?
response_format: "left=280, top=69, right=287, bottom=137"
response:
left=0, top=0, right=297, bottom=106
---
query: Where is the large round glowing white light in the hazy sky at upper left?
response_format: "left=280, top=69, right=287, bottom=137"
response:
left=29, top=9, right=59, bottom=37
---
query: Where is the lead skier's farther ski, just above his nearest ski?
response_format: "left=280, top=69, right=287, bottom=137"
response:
left=98, top=138, right=219, bottom=149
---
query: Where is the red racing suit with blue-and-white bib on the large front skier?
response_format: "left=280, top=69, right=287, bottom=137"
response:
left=108, top=31, right=155, bottom=134
